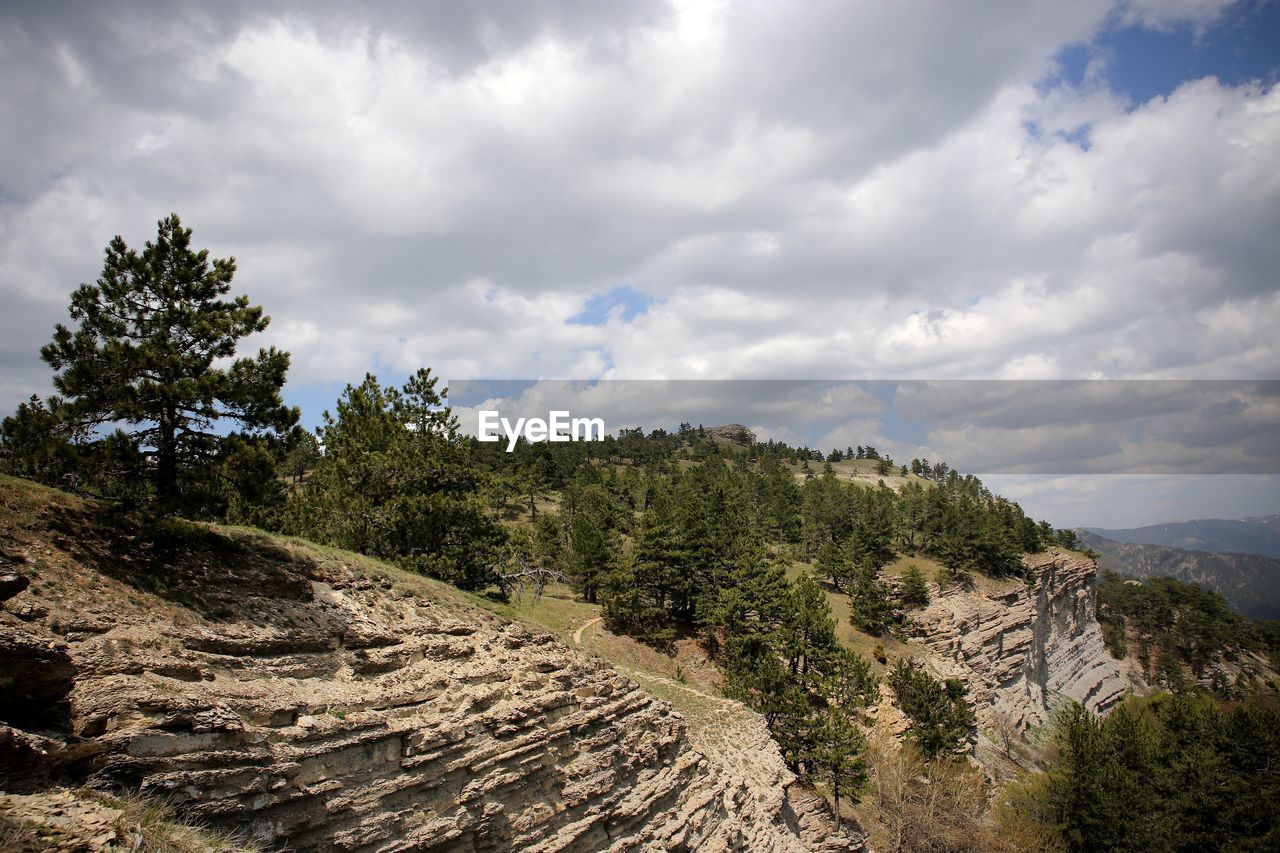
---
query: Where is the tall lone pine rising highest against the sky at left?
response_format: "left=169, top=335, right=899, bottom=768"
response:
left=40, top=214, right=298, bottom=511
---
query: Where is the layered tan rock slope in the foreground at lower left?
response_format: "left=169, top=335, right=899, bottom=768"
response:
left=0, top=480, right=858, bottom=850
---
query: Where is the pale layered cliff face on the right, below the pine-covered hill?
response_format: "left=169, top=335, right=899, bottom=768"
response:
left=914, top=551, right=1133, bottom=733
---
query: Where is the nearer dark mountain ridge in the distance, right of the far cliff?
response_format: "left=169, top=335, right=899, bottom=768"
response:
left=1079, top=525, right=1280, bottom=619
